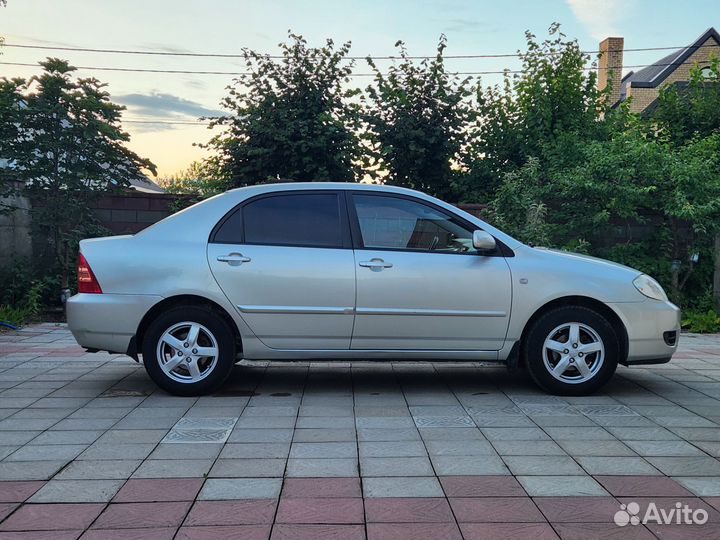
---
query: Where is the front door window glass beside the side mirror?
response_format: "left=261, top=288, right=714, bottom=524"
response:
left=353, top=195, right=476, bottom=253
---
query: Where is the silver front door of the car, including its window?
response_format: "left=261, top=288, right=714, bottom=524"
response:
left=350, top=192, right=511, bottom=351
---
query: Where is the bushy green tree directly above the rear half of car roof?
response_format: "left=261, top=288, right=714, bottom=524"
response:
left=206, top=33, right=360, bottom=186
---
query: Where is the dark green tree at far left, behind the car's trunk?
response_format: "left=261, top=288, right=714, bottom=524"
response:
left=0, top=58, right=155, bottom=288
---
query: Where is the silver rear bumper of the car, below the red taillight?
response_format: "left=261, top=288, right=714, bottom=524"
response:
left=67, top=293, right=162, bottom=354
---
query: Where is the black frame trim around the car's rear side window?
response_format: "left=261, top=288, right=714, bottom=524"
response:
left=208, top=189, right=352, bottom=249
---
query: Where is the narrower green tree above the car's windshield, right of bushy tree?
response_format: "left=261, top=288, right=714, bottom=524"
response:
left=364, top=36, right=472, bottom=197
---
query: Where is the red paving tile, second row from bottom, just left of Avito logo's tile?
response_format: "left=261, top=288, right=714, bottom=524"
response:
left=450, top=497, right=545, bottom=523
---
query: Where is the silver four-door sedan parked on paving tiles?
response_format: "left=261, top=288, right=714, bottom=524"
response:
left=67, top=183, right=680, bottom=395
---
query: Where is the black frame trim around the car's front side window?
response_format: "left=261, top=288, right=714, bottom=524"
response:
left=345, top=189, right=515, bottom=257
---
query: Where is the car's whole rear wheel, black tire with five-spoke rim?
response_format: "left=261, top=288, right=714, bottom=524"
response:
left=142, top=306, right=235, bottom=396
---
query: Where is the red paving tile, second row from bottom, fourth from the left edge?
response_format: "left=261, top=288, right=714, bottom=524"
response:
left=275, top=498, right=365, bottom=523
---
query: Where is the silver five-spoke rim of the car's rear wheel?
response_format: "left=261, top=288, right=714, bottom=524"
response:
left=157, top=321, right=219, bottom=384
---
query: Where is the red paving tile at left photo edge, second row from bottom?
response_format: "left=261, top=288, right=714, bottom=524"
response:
left=0, top=504, right=105, bottom=531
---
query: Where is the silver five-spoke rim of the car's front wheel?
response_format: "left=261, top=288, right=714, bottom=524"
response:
left=543, top=322, right=605, bottom=384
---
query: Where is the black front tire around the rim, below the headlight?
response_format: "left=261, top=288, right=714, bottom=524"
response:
left=522, top=306, right=621, bottom=396
